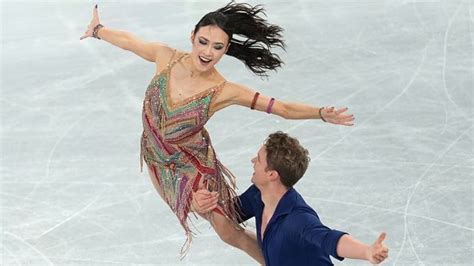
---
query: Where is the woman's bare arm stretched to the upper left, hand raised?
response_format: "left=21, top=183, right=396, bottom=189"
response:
left=80, top=5, right=172, bottom=62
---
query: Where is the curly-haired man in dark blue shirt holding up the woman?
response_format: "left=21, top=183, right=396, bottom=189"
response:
left=193, top=131, right=388, bottom=266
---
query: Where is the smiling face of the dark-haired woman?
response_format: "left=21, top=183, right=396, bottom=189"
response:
left=191, top=25, right=229, bottom=72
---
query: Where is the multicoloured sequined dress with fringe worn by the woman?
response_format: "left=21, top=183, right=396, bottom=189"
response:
left=141, top=51, right=237, bottom=255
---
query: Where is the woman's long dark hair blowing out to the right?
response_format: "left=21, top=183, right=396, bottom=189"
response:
left=194, top=1, right=285, bottom=77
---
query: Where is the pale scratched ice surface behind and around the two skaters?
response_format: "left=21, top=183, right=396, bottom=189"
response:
left=0, top=0, right=474, bottom=265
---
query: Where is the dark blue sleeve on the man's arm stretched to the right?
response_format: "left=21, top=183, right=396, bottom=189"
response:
left=303, top=214, right=347, bottom=261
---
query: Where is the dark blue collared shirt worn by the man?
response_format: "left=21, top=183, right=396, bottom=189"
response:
left=239, top=185, right=346, bottom=266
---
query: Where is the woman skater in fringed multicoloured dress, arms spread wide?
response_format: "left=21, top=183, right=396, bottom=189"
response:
left=81, top=2, right=354, bottom=264
